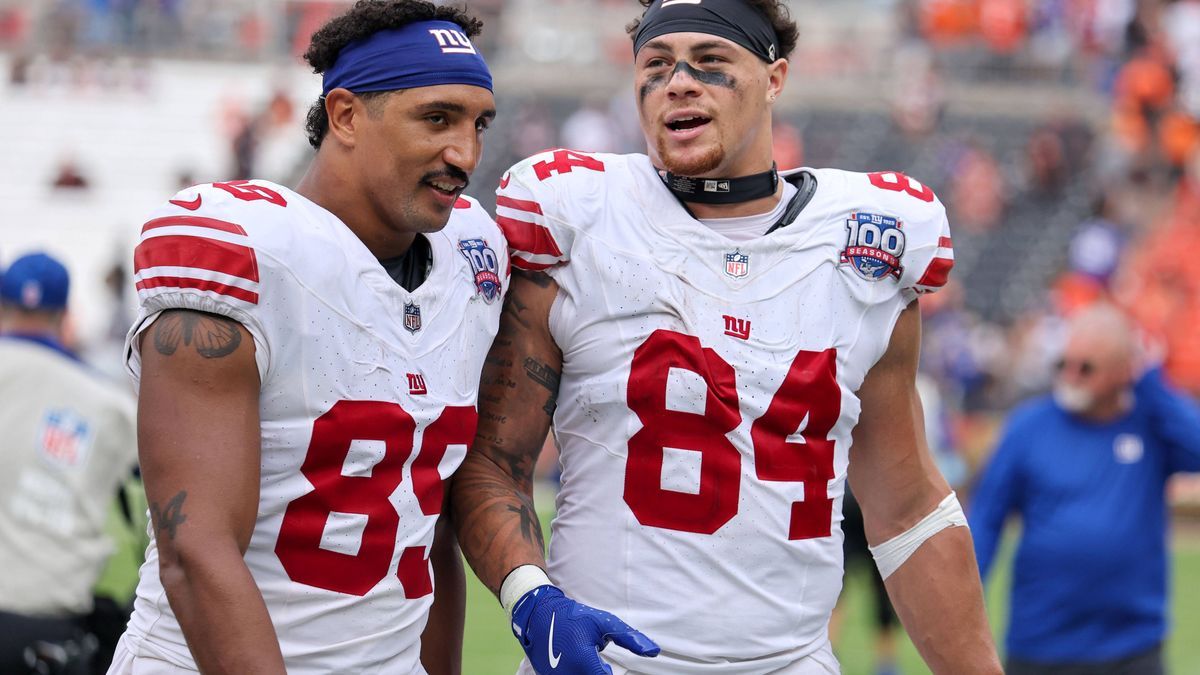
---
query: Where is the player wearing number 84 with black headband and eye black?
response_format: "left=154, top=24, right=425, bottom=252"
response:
left=451, top=0, right=1001, bottom=675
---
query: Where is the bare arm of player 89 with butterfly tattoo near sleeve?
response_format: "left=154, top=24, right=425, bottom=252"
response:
left=138, top=310, right=284, bottom=673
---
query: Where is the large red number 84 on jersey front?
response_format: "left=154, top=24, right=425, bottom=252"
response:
left=624, top=329, right=841, bottom=539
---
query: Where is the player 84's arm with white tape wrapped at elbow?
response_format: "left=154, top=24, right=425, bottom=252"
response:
left=850, top=303, right=1002, bottom=675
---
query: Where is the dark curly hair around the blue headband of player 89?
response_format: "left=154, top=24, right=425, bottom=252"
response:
left=304, top=0, right=484, bottom=148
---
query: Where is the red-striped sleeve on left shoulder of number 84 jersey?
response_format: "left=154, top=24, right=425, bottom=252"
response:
left=496, top=150, right=608, bottom=271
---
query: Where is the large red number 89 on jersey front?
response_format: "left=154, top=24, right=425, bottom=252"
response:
left=275, top=401, right=478, bottom=599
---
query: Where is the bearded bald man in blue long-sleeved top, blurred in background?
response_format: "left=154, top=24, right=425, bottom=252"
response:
left=968, top=305, right=1200, bottom=675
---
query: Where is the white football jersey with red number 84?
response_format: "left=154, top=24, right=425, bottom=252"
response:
left=497, top=150, right=953, bottom=674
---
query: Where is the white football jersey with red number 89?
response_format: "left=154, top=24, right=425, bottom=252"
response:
left=118, top=181, right=508, bottom=674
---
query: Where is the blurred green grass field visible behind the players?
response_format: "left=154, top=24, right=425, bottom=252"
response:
left=101, top=487, right=1200, bottom=675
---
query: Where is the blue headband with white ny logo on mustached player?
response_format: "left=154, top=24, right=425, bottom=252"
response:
left=322, top=22, right=492, bottom=96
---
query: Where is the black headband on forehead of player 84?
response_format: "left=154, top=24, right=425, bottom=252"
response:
left=634, top=0, right=781, bottom=64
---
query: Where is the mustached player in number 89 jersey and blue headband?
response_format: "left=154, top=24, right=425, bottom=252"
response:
left=112, top=0, right=508, bottom=675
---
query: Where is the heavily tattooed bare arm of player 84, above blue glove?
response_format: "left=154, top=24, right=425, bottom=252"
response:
left=450, top=269, right=563, bottom=593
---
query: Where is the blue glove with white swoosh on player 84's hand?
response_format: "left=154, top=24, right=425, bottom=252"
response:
left=512, top=586, right=659, bottom=675
